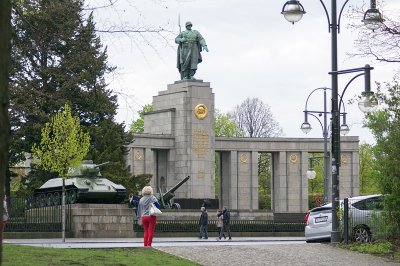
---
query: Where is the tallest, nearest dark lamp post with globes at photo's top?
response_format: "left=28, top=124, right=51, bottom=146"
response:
left=281, top=0, right=383, bottom=243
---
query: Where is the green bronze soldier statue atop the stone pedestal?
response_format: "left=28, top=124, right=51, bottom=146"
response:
left=175, top=21, right=208, bottom=80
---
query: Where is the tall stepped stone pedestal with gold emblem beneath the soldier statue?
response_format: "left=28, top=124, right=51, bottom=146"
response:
left=143, top=80, right=215, bottom=199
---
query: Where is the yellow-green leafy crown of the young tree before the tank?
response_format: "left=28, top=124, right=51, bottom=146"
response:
left=32, top=104, right=90, bottom=178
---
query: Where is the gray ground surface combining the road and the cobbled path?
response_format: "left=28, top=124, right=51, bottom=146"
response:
left=5, top=237, right=400, bottom=266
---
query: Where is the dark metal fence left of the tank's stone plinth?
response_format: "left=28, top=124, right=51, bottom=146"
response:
left=6, top=197, right=71, bottom=232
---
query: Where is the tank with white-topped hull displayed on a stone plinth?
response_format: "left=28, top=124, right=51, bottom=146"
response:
left=32, top=160, right=126, bottom=207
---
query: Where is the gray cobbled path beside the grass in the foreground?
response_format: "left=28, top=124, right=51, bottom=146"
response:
left=157, top=244, right=400, bottom=266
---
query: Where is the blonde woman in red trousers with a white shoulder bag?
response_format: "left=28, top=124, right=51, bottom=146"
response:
left=137, top=186, right=160, bottom=247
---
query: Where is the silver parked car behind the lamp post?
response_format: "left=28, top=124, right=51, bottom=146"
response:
left=304, top=194, right=383, bottom=243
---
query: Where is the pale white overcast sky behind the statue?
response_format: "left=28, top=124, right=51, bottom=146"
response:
left=89, top=0, right=400, bottom=143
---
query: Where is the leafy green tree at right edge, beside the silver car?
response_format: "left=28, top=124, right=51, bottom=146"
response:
left=366, top=82, right=400, bottom=237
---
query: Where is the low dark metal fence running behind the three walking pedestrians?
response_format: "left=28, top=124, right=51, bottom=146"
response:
left=133, top=220, right=305, bottom=232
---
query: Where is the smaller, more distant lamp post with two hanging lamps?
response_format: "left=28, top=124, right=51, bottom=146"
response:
left=300, top=88, right=349, bottom=204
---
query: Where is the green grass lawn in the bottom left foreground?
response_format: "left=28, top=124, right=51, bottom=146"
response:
left=1, top=244, right=199, bottom=266
